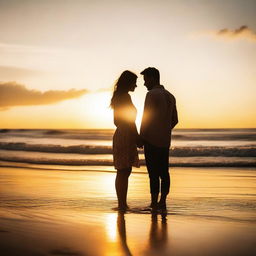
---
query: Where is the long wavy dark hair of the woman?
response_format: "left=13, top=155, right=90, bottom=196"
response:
left=110, top=70, right=137, bottom=108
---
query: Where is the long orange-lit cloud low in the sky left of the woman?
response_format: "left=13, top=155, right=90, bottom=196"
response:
left=0, top=82, right=88, bottom=110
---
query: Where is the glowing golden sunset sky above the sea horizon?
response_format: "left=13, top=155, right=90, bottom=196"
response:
left=0, top=0, right=256, bottom=129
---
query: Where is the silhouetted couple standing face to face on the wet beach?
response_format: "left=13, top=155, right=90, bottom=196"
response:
left=111, top=68, right=178, bottom=210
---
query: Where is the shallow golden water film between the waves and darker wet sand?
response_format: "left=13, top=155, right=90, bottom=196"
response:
left=0, top=166, right=256, bottom=221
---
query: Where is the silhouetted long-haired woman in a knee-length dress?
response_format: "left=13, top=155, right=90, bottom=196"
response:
left=110, top=70, right=142, bottom=211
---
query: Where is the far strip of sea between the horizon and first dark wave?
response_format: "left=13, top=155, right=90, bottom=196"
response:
left=0, top=129, right=256, bottom=141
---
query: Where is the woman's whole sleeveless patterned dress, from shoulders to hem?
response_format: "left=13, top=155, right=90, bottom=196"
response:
left=113, top=93, right=139, bottom=170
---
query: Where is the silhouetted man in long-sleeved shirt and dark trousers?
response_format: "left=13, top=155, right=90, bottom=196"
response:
left=140, top=67, right=178, bottom=210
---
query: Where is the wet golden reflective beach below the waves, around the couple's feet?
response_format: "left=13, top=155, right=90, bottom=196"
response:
left=0, top=166, right=256, bottom=256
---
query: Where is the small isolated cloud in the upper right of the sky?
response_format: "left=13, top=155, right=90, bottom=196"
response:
left=214, top=25, right=256, bottom=42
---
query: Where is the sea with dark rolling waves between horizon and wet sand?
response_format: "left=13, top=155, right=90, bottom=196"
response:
left=0, top=129, right=256, bottom=170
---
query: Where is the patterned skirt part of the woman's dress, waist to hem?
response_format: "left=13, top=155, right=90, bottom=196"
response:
left=113, top=127, right=140, bottom=170
